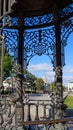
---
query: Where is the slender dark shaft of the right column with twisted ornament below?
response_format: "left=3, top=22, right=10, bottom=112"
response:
left=54, top=4, right=63, bottom=118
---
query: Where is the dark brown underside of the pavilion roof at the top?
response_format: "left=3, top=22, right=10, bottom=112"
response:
left=12, top=0, right=73, bottom=17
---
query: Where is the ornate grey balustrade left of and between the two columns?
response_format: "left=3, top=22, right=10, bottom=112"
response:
left=0, top=95, right=56, bottom=130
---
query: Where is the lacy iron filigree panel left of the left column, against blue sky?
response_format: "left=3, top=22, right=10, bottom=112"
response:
left=3, top=29, right=18, bottom=56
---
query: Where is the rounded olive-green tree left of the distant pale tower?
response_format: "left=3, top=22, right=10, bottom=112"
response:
left=35, top=78, right=44, bottom=92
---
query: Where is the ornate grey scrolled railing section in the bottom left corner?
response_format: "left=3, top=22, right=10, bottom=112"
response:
left=0, top=96, right=16, bottom=130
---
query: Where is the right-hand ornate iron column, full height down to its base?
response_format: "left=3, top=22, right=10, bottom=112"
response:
left=54, top=6, right=67, bottom=130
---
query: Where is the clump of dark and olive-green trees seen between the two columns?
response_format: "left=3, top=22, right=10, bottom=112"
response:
left=24, top=70, right=45, bottom=93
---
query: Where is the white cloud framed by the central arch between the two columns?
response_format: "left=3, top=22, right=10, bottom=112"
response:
left=28, top=63, right=54, bottom=83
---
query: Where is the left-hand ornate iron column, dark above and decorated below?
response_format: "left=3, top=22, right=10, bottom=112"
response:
left=16, top=13, right=24, bottom=130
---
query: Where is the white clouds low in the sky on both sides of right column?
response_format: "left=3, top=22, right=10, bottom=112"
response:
left=28, top=63, right=73, bottom=86
